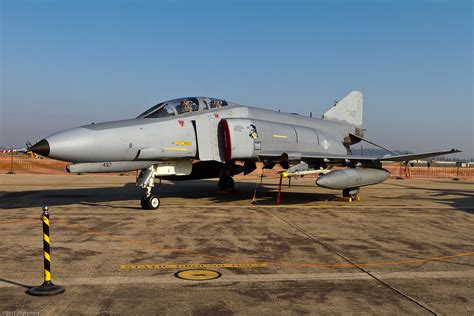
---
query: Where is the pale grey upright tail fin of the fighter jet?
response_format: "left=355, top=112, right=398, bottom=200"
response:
left=323, top=91, right=364, bottom=126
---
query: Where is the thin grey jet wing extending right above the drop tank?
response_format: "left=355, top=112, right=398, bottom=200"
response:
left=259, top=149, right=461, bottom=164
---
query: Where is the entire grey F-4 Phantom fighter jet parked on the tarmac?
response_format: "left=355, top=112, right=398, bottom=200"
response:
left=28, top=91, right=460, bottom=209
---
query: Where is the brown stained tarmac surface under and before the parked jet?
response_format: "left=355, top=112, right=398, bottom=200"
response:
left=0, top=175, right=474, bottom=315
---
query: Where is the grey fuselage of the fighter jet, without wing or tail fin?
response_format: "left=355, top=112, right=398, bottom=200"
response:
left=32, top=97, right=356, bottom=163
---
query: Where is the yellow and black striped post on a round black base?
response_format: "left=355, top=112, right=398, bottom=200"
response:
left=28, top=206, right=65, bottom=295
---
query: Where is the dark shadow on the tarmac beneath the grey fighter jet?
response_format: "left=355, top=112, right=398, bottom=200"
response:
left=0, top=180, right=338, bottom=209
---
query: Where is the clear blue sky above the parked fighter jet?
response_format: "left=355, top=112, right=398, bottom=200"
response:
left=0, top=0, right=474, bottom=157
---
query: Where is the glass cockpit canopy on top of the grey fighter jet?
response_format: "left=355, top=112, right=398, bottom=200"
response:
left=137, top=97, right=229, bottom=118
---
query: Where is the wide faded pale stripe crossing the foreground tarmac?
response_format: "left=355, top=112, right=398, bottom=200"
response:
left=0, top=269, right=474, bottom=288
